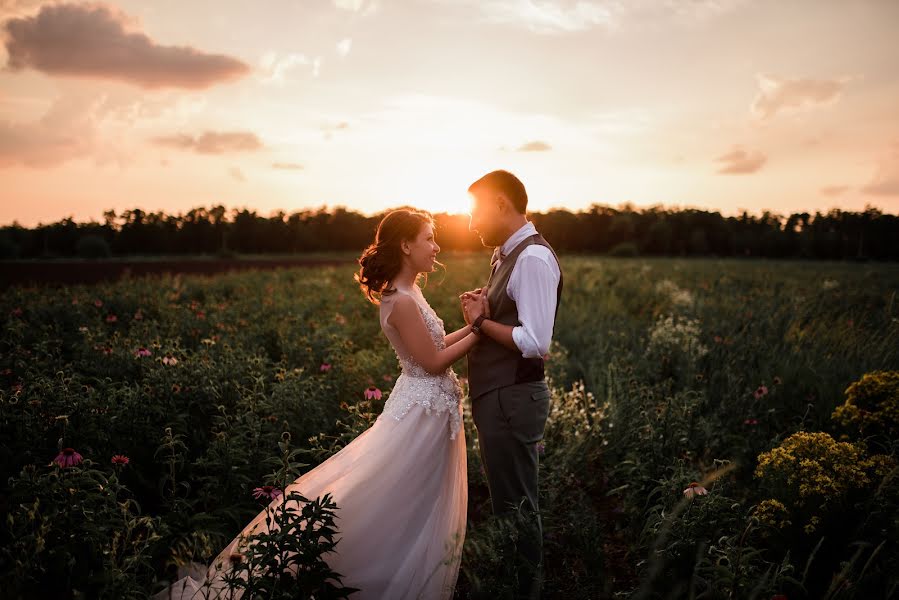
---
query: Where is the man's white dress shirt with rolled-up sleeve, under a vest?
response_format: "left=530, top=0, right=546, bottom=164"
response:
left=494, top=221, right=561, bottom=358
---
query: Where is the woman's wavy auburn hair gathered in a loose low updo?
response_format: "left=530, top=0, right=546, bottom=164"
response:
left=353, top=209, right=439, bottom=304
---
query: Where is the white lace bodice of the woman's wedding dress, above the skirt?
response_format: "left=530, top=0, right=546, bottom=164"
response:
left=380, top=286, right=462, bottom=439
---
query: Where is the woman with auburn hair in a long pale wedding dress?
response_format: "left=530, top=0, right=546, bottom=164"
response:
left=153, top=210, right=489, bottom=600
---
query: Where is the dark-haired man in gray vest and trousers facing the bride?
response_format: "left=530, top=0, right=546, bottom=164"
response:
left=459, top=171, right=562, bottom=598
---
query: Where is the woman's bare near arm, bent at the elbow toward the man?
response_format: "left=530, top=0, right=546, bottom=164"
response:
left=388, top=296, right=478, bottom=375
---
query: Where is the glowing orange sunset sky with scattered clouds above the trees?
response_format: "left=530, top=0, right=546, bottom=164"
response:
left=0, top=0, right=899, bottom=226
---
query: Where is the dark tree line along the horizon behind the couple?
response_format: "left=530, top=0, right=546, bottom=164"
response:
left=0, top=204, right=899, bottom=260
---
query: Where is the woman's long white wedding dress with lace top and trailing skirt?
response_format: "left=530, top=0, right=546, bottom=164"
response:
left=153, top=285, right=468, bottom=600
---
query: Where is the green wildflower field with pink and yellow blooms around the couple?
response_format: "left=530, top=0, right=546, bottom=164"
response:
left=0, top=254, right=899, bottom=600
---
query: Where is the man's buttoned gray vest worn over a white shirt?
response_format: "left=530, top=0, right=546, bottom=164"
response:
left=468, top=233, right=562, bottom=399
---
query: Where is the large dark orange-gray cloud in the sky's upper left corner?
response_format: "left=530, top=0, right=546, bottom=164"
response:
left=4, top=4, right=250, bottom=89
